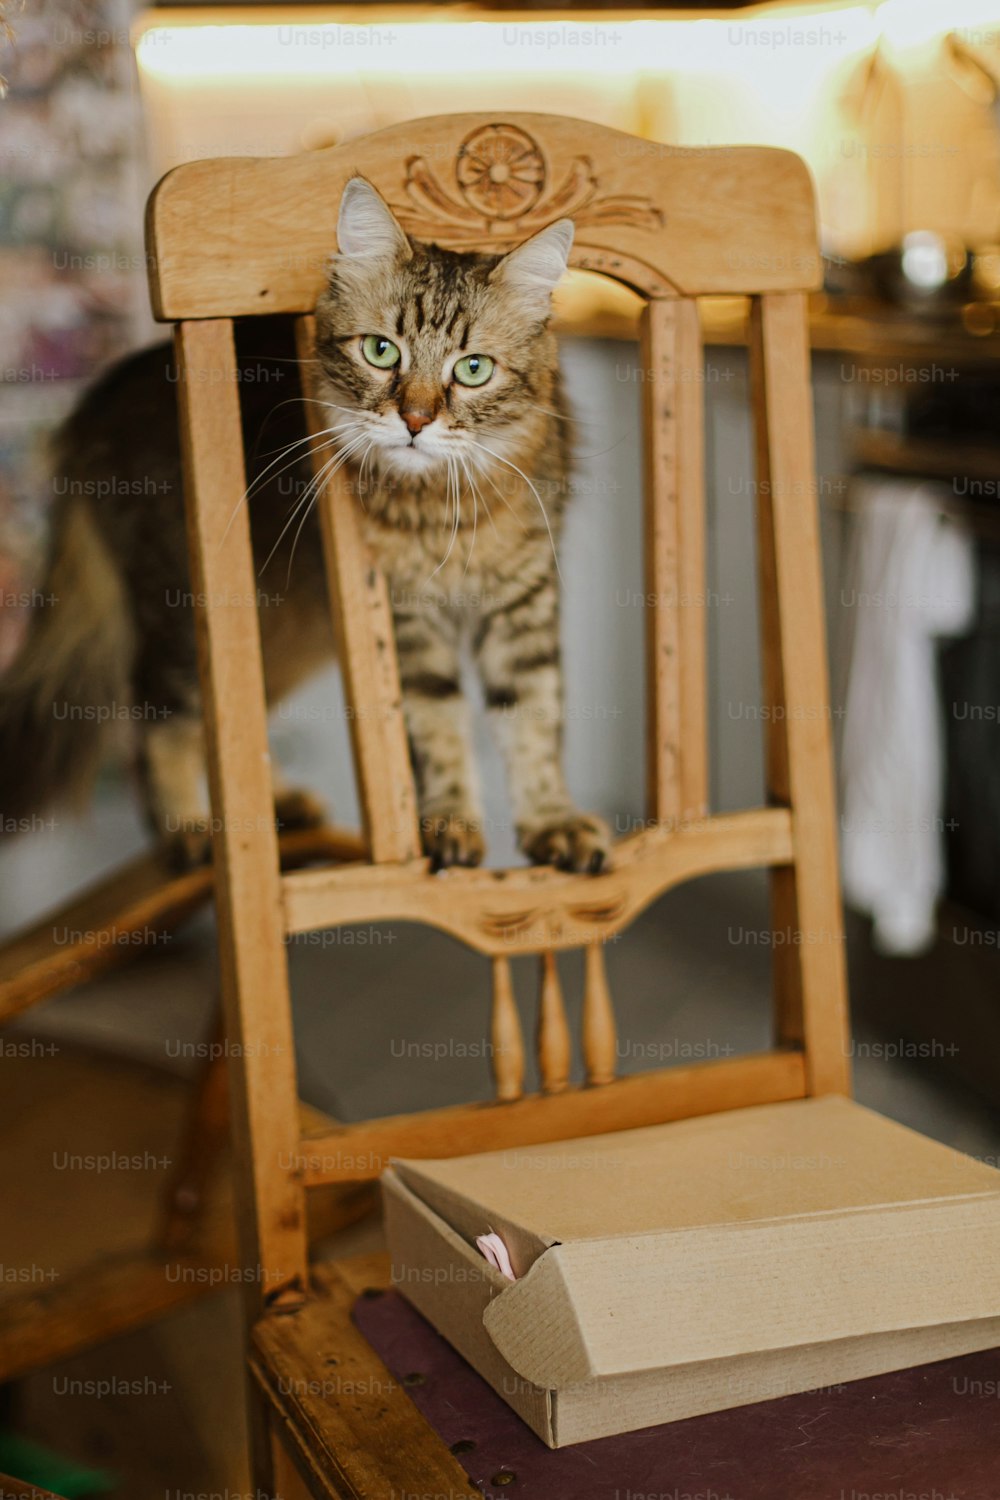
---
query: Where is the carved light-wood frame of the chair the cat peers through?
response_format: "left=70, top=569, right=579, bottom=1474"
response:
left=148, top=114, right=849, bottom=1500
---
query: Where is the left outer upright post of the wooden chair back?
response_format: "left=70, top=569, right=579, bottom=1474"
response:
left=177, top=320, right=306, bottom=1304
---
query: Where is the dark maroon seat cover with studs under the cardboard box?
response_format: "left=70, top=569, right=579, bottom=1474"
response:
left=354, top=1292, right=1000, bottom=1500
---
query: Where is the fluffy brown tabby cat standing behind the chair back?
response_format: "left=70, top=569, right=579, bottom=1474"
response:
left=0, top=177, right=609, bottom=872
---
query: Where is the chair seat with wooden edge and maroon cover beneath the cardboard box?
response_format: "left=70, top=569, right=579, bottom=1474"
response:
left=250, top=1256, right=1000, bottom=1500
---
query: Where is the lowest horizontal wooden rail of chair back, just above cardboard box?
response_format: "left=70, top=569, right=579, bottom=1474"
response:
left=298, top=1050, right=805, bottom=1188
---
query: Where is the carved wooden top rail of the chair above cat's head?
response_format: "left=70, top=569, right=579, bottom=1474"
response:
left=147, top=111, right=820, bottom=320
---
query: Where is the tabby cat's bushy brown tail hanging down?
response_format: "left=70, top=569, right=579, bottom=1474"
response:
left=0, top=500, right=132, bottom=834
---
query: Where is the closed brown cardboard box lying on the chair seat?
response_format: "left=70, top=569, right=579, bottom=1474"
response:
left=382, top=1098, right=1000, bottom=1448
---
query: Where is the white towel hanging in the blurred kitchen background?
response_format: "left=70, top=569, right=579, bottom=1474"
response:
left=841, top=480, right=975, bottom=954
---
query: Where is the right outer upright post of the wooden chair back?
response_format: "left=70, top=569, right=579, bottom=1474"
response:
left=751, top=294, right=850, bottom=1094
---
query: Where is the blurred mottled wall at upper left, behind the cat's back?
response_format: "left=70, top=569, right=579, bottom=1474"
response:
left=0, top=0, right=148, bottom=665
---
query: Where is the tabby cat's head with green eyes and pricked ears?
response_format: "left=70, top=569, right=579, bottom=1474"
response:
left=316, top=177, right=573, bottom=480
